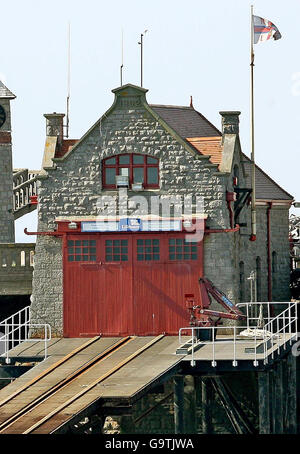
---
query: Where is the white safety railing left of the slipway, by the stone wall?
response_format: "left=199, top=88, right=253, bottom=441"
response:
left=0, top=306, right=51, bottom=364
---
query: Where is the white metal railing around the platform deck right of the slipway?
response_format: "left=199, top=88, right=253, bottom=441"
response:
left=179, top=302, right=297, bottom=367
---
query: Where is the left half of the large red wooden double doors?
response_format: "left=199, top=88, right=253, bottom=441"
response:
left=64, top=235, right=133, bottom=337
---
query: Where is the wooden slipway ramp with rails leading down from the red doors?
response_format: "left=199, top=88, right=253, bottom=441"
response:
left=0, top=335, right=182, bottom=434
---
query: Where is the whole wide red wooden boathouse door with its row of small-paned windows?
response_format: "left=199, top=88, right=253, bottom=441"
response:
left=64, top=233, right=203, bottom=337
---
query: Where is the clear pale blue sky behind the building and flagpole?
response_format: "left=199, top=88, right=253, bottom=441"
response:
left=0, top=0, right=300, bottom=241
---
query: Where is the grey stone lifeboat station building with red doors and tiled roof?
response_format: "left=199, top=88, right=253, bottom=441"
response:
left=28, top=84, right=293, bottom=338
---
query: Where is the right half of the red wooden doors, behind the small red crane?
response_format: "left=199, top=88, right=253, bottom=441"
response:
left=133, top=234, right=203, bottom=335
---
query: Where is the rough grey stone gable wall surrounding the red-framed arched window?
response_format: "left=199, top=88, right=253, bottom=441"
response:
left=39, top=87, right=227, bottom=229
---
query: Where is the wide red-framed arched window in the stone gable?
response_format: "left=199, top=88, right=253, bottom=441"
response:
left=102, top=153, right=159, bottom=189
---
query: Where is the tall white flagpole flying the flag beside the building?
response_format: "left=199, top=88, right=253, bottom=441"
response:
left=250, top=5, right=256, bottom=241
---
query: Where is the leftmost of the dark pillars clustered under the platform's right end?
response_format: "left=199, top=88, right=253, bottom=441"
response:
left=258, top=371, right=271, bottom=434
